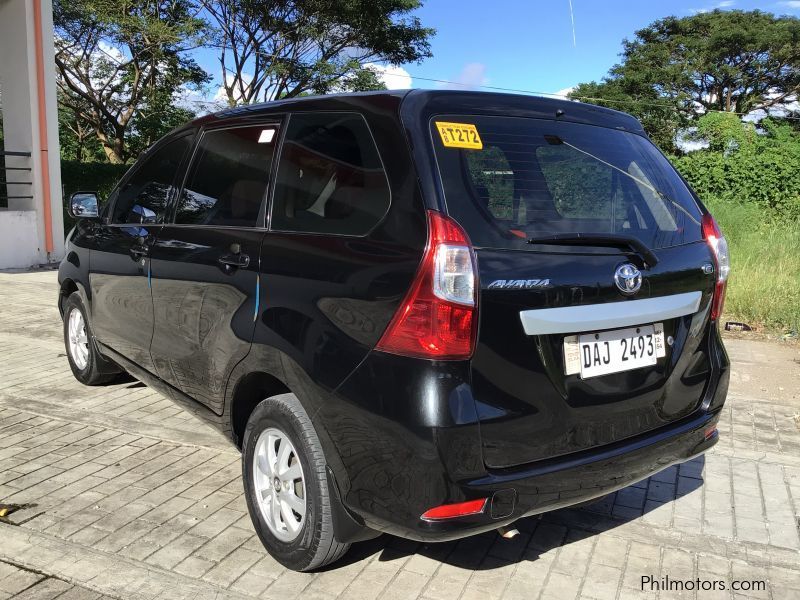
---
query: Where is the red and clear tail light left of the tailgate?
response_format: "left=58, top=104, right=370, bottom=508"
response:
left=376, top=210, right=477, bottom=360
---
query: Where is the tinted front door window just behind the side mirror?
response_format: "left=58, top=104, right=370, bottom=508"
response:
left=111, top=135, right=192, bottom=223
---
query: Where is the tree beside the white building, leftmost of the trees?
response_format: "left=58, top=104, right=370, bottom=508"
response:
left=53, top=0, right=208, bottom=163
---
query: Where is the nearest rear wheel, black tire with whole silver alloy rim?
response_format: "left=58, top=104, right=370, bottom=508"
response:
left=242, top=394, right=350, bottom=571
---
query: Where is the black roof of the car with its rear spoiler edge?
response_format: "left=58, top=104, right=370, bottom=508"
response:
left=189, top=89, right=644, bottom=134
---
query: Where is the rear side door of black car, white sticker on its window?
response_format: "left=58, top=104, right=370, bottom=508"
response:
left=150, top=123, right=278, bottom=413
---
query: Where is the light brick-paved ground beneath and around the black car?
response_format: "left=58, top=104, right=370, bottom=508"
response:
left=0, top=272, right=800, bottom=600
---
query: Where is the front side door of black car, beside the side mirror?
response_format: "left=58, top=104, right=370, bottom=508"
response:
left=89, top=134, right=192, bottom=372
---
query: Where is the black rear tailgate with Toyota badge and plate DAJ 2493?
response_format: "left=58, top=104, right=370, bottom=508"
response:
left=431, top=116, right=715, bottom=467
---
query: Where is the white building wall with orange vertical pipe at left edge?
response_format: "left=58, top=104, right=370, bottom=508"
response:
left=0, top=0, right=64, bottom=268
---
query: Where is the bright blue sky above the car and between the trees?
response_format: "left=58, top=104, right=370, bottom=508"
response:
left=186, top=0, right=800, bottom=106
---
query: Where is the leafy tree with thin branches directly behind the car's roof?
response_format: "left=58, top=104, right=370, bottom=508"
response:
left=199, top=0, right=434, bottom=105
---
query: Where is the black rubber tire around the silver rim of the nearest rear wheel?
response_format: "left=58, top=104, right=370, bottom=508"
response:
left=242, top=394, right=350, bottom=571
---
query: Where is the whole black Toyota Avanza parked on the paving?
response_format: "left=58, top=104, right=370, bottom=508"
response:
left=59, top=90, right=729, bottom=570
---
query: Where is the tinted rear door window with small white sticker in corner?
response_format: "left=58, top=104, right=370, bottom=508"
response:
left=175, top=125, right=277, bottom=227
